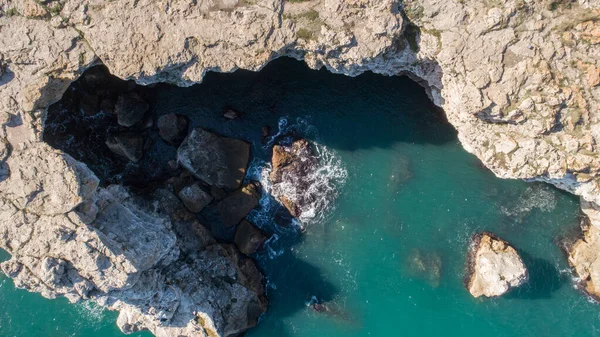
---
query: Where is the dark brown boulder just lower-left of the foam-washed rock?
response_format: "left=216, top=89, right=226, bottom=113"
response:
left=217, top=182, right=260, bottom=227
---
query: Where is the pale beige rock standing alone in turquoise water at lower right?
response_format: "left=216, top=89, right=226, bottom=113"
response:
left=466, top=232, right=528, bottom=297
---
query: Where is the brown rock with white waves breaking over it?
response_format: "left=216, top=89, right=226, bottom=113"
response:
left=269, top=139, right=319, bottom=217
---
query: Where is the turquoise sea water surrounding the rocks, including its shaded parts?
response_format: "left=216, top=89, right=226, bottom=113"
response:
left=0, top=59, right=600, bottom=337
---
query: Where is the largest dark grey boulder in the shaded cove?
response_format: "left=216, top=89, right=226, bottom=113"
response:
left=177, top=128, right=250, bottom=190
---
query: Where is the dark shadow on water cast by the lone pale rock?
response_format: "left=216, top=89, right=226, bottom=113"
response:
left=506, top=251, right=569, bottom=300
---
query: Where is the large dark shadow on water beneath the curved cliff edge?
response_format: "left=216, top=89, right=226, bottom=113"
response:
left=44, top=58, right=456, bottom=186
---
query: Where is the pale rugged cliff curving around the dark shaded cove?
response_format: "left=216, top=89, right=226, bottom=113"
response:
left=0, top=0, right=600, bottom=336
